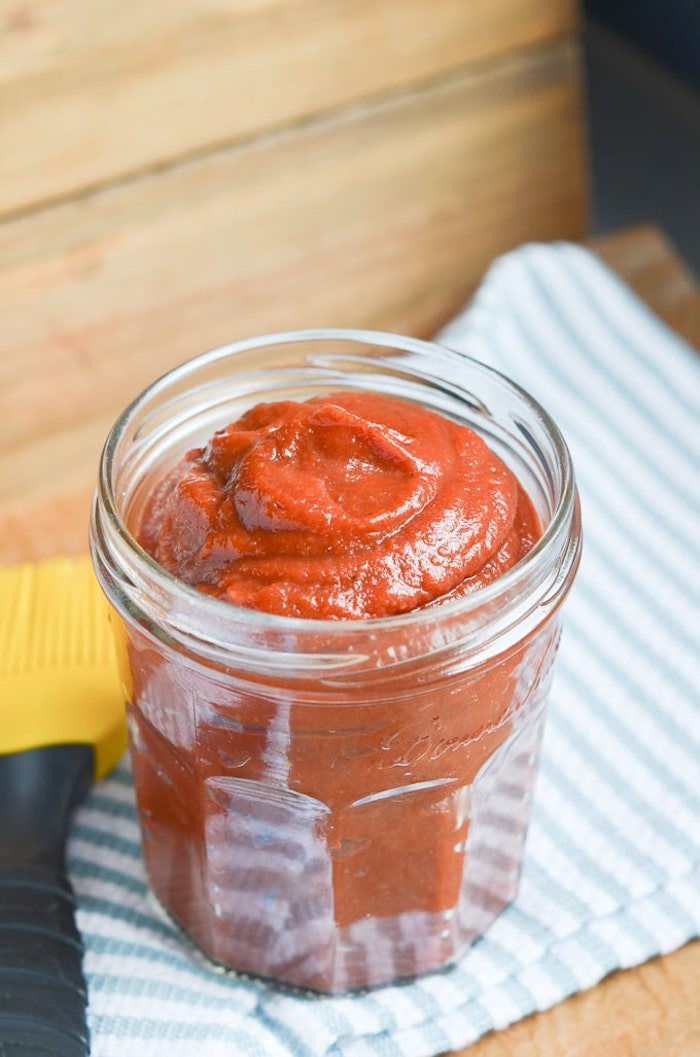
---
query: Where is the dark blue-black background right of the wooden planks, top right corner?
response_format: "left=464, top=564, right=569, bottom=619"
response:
left=584, top=0, right=700, bottom=277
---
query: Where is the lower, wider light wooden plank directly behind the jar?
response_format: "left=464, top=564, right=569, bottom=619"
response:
left=0, top=38, right=584, bottom=558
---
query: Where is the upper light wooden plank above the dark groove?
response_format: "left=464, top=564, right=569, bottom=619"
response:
left=0, top=0, right=576, bottom=216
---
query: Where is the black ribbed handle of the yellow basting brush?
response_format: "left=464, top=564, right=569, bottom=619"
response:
left=0, top=745, right=94, bottom=1057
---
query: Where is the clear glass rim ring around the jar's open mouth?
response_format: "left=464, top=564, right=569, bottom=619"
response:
left=91, top=328, right=581, bottom=659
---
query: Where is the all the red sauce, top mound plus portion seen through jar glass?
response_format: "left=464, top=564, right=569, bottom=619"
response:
left=123, top=392, right=558, bottom=991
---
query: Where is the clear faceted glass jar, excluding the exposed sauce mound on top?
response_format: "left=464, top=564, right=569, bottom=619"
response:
left=91, top=330, right=581, bottom=993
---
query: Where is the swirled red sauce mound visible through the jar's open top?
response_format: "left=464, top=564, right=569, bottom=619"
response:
left=139, top=392, right=539, bottom=619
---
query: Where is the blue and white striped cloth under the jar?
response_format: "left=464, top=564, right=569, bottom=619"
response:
left=70, top=243, right=700, bottom=1057
